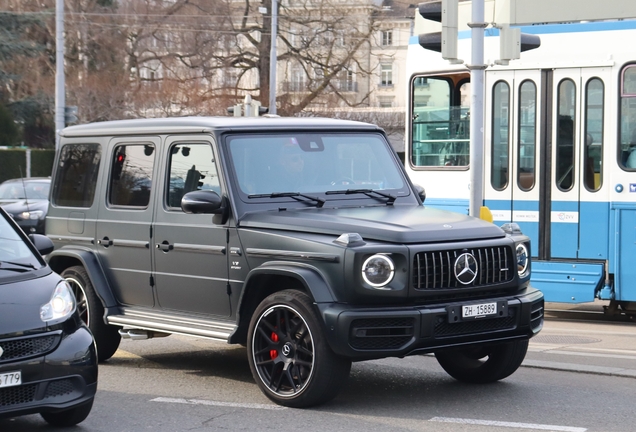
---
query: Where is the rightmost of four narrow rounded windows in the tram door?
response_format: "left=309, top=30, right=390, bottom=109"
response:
left=582, top=78, right=605, bottom=191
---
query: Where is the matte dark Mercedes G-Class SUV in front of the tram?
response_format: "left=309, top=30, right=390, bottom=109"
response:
left=46, top=117, right=543, bottom=407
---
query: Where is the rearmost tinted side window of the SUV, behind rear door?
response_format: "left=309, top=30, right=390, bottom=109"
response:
left=51, top=144, right=102, bottom=208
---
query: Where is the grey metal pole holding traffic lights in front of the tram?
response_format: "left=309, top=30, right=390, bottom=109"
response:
left=468, top=0, right=487, bottom=217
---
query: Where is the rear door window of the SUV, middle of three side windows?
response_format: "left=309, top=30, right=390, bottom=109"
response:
left=108, top=144, right=155, bottom=208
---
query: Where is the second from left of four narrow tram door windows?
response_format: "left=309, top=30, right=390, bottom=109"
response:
left=517, top=81, right=537, bottom=191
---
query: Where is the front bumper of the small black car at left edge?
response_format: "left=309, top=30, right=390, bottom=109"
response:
left=0, top=326, right=97, bottom=417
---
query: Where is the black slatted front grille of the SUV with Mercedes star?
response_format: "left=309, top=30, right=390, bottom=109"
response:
left=413, top=246, right=516, bottom=290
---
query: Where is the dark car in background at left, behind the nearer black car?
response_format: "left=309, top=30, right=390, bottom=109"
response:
left=0, top=177, right=51, bottom=234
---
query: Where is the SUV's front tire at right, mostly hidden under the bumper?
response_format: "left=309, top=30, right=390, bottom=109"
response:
left=435, top=339, right=528, bottom=384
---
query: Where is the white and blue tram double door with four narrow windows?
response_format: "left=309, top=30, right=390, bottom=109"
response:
left=484, top=68, right=609, bottom=260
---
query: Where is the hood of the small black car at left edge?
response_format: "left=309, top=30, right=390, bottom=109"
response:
left=0, top=271, right=61, bottom=337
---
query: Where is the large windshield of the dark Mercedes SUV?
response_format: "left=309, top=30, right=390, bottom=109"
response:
left=228, top=133, right=408, bottom=198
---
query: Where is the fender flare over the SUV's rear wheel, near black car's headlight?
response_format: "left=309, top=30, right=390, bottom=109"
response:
left=46, top=247, right=118, bottom=310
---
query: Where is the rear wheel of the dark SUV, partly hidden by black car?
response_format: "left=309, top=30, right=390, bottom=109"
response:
left=62, top=266, right=121, bottom=362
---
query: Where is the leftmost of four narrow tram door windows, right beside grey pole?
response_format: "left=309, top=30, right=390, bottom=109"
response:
left=490, top=81, right=510, bottom=190
